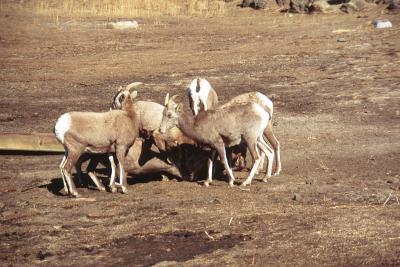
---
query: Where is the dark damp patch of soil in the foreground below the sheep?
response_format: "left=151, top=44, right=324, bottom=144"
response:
left=95, top=231, right=252, bottom=266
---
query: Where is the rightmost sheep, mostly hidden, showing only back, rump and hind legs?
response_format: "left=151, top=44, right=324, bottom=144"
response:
left=220, top=92, right=282, bottom=177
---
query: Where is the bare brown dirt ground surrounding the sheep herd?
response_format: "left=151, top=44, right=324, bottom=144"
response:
left=0, top=6, right=400, bottom=266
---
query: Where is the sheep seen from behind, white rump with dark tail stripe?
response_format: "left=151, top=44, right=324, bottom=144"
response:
left=188, top=78, right=218, bottom=115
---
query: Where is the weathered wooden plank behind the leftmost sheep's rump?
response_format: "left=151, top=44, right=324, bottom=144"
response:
left=0, top=133, right=64, bottom=152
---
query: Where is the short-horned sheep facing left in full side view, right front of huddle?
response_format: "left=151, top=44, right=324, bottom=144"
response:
left=160, top=94, right=270, bottom=186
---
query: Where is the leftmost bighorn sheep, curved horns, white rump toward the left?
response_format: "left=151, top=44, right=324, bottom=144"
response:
left=54, top=83, right=141, bottom=197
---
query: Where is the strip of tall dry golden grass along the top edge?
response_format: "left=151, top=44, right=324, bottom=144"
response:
left=0, top=0, right=226, bottom=18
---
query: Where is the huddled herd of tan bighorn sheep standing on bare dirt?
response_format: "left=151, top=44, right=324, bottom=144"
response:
left=54, top=78, right=281, bottom=197
